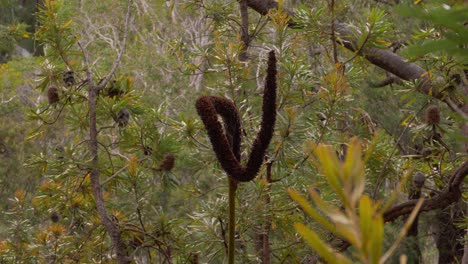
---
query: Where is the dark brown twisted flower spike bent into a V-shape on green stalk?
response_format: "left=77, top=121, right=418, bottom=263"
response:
left=195, top=51, right=277, bottom=182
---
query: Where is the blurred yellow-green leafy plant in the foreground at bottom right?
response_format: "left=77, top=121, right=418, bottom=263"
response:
left=288, top=138, right=423, bottom=264
